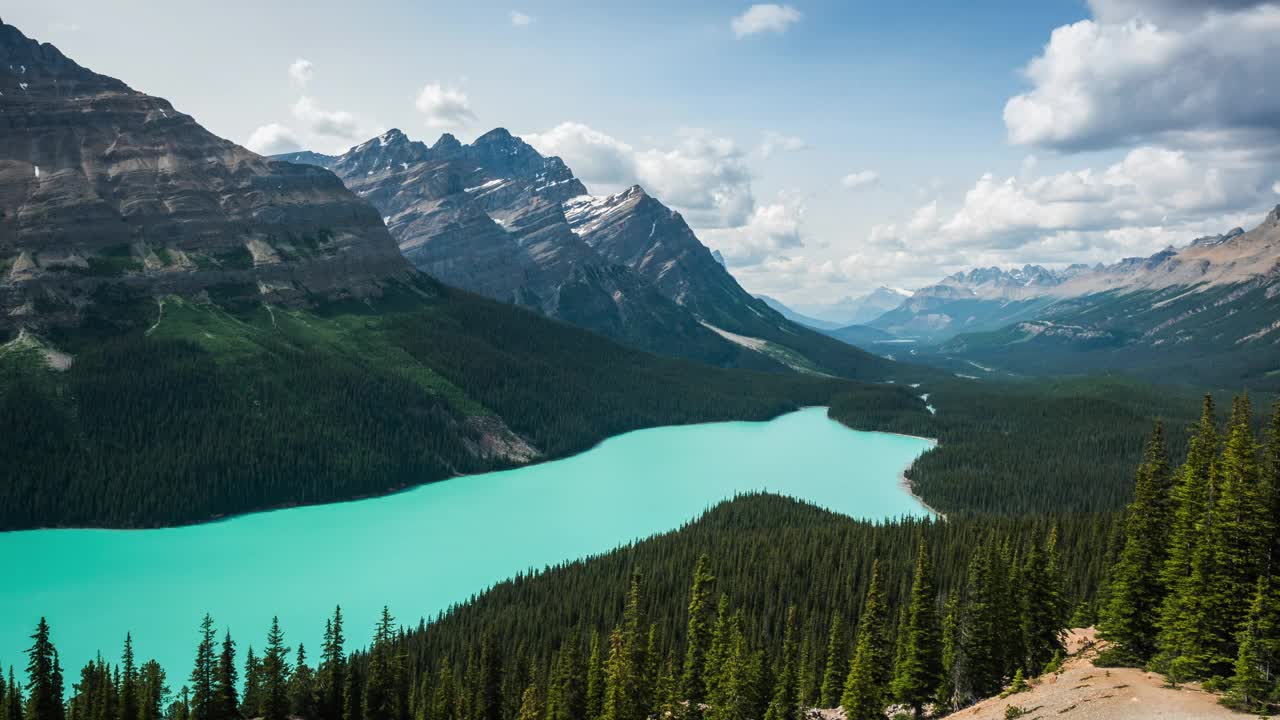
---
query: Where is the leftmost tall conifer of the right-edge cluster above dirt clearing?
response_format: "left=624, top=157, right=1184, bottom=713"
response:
left=1100, top=421, right=1171, bottom=665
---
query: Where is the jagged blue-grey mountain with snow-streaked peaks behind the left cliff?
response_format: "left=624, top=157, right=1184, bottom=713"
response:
left=276, top=128, right=901, bottom=375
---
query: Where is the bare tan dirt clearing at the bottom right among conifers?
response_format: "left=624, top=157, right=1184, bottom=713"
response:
left=947, top=628, right=1256, bottom=720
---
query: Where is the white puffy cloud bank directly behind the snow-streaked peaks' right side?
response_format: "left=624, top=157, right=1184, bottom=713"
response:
left=525, top=122, right=755, bottom=227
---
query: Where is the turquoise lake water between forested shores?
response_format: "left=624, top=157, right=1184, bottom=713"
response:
left=0, top=407, right=932, bottom=676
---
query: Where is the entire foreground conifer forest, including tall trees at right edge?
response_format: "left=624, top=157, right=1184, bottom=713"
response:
left=3, top=396, right=1280, bottom=720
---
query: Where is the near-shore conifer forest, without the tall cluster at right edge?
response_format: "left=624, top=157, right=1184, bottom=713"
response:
left=0, top=496, right=1110, bottom=720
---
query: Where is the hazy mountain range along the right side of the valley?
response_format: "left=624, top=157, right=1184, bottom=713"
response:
left=870, top=215, right=1280, bottom=388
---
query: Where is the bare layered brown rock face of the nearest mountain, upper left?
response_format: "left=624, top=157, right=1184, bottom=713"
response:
left=0, top=23, right=411, bottom=331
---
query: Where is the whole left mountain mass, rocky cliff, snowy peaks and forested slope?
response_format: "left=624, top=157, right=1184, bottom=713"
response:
left=0, top=23, right=910, bottom=529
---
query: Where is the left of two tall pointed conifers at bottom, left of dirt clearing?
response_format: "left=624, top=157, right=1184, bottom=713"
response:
left=840, top=560, right=892, bottom=720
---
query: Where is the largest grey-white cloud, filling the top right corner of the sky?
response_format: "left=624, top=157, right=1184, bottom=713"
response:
left=1004, top=0, right=1280, bottom=150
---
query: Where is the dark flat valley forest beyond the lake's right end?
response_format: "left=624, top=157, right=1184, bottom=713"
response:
left=831, top=375, right=1263, bottom=512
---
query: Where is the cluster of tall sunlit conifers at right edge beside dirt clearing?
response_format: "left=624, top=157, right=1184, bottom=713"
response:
left=1100, top=395, right=1280, bottom=711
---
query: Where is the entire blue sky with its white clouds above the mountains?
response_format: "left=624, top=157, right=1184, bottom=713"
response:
left=4, top=0, right=1280, bottom=304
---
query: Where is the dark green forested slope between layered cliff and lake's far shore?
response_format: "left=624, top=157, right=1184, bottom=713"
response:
left=0, top=275, right=855, bottom=529
